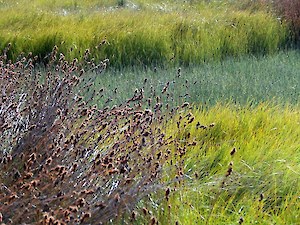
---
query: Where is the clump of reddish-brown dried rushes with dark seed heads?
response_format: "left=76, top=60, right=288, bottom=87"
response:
left=0, top=43, right=185, bottom=224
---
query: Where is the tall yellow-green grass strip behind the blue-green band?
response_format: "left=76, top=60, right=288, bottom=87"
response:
left=0, top=0, right=287, bottom=67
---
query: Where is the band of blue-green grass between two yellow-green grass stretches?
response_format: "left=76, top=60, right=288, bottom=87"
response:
left=84, top=51, right=300, bottom=107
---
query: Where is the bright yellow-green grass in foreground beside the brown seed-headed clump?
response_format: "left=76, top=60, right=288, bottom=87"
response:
left=152, top=103, right=300, bottom=224
